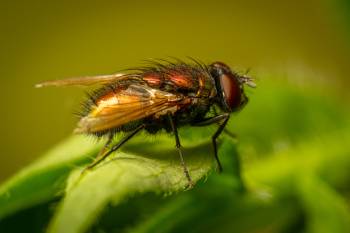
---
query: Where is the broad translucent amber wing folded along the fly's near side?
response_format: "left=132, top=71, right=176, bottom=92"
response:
left=75, top=84, right=190, bottom=133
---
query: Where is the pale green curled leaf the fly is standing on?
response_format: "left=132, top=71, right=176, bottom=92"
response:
left=49, top=137, right=213, bottom=233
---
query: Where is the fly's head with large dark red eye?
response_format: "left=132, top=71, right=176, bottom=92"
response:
left=209, top=62, right=255, bottom=112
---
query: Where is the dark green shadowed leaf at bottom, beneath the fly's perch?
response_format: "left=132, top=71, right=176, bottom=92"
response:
left=124, top=171, right=300, bottom=233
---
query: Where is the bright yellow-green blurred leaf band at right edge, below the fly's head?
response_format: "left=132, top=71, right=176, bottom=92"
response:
left=244, top=127, right=350, bottom=193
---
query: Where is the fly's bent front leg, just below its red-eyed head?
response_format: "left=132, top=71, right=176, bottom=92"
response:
left=193, top=113, right=230, bottom=172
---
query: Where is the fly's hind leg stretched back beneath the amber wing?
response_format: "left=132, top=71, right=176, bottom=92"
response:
left=83, top=125, right=145, bottom=173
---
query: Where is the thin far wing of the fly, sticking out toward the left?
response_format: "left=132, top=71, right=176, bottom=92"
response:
left=35, top=74, right=138, bottom=88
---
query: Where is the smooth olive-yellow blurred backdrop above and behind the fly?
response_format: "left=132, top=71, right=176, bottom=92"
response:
left=0, top=0, right=350, bottom=181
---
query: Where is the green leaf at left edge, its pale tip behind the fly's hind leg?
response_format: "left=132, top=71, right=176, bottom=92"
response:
left=0, top=136, right=100, bottom=220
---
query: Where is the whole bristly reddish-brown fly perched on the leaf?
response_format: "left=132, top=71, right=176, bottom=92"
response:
left=36, top=59, right=255, bottom=187
